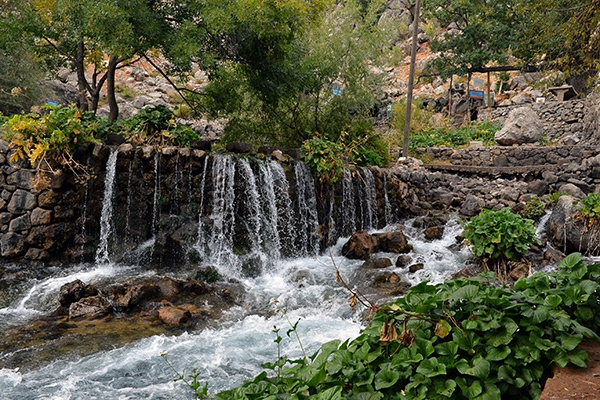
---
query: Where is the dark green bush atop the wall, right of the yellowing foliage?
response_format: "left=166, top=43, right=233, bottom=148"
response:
left=120, top=105, right=201, bottom=146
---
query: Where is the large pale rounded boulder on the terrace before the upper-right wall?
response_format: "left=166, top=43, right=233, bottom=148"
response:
left=494, top=107, right=544, bottom=146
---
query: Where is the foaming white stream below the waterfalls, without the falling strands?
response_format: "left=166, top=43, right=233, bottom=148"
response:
left=0, top=222, right=469, bottom=399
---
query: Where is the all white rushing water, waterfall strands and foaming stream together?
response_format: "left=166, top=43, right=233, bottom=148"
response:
left=0, top=152, right=478, bottom=400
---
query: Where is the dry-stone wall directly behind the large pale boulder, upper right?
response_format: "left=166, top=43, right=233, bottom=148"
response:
left=478, top=98, right=592, bottom=145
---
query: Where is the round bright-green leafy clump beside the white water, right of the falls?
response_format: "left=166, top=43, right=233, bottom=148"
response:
left=463, top=207, right=538, bottom=260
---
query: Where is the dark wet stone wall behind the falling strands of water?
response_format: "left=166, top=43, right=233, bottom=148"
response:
left=0, top=142, right=411, bottom=265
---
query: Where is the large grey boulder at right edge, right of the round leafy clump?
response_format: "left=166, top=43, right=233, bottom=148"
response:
left=547, top=196, right=600, bottom=255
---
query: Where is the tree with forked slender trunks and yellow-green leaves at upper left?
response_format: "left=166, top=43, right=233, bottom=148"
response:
left=7, top=0, right=168, bottom=121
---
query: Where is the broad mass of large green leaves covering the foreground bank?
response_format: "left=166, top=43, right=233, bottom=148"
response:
left=202, top=254, right=600, bottom=400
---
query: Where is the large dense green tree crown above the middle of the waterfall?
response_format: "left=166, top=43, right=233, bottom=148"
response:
left=164, top=0, right=394, bottom=146
